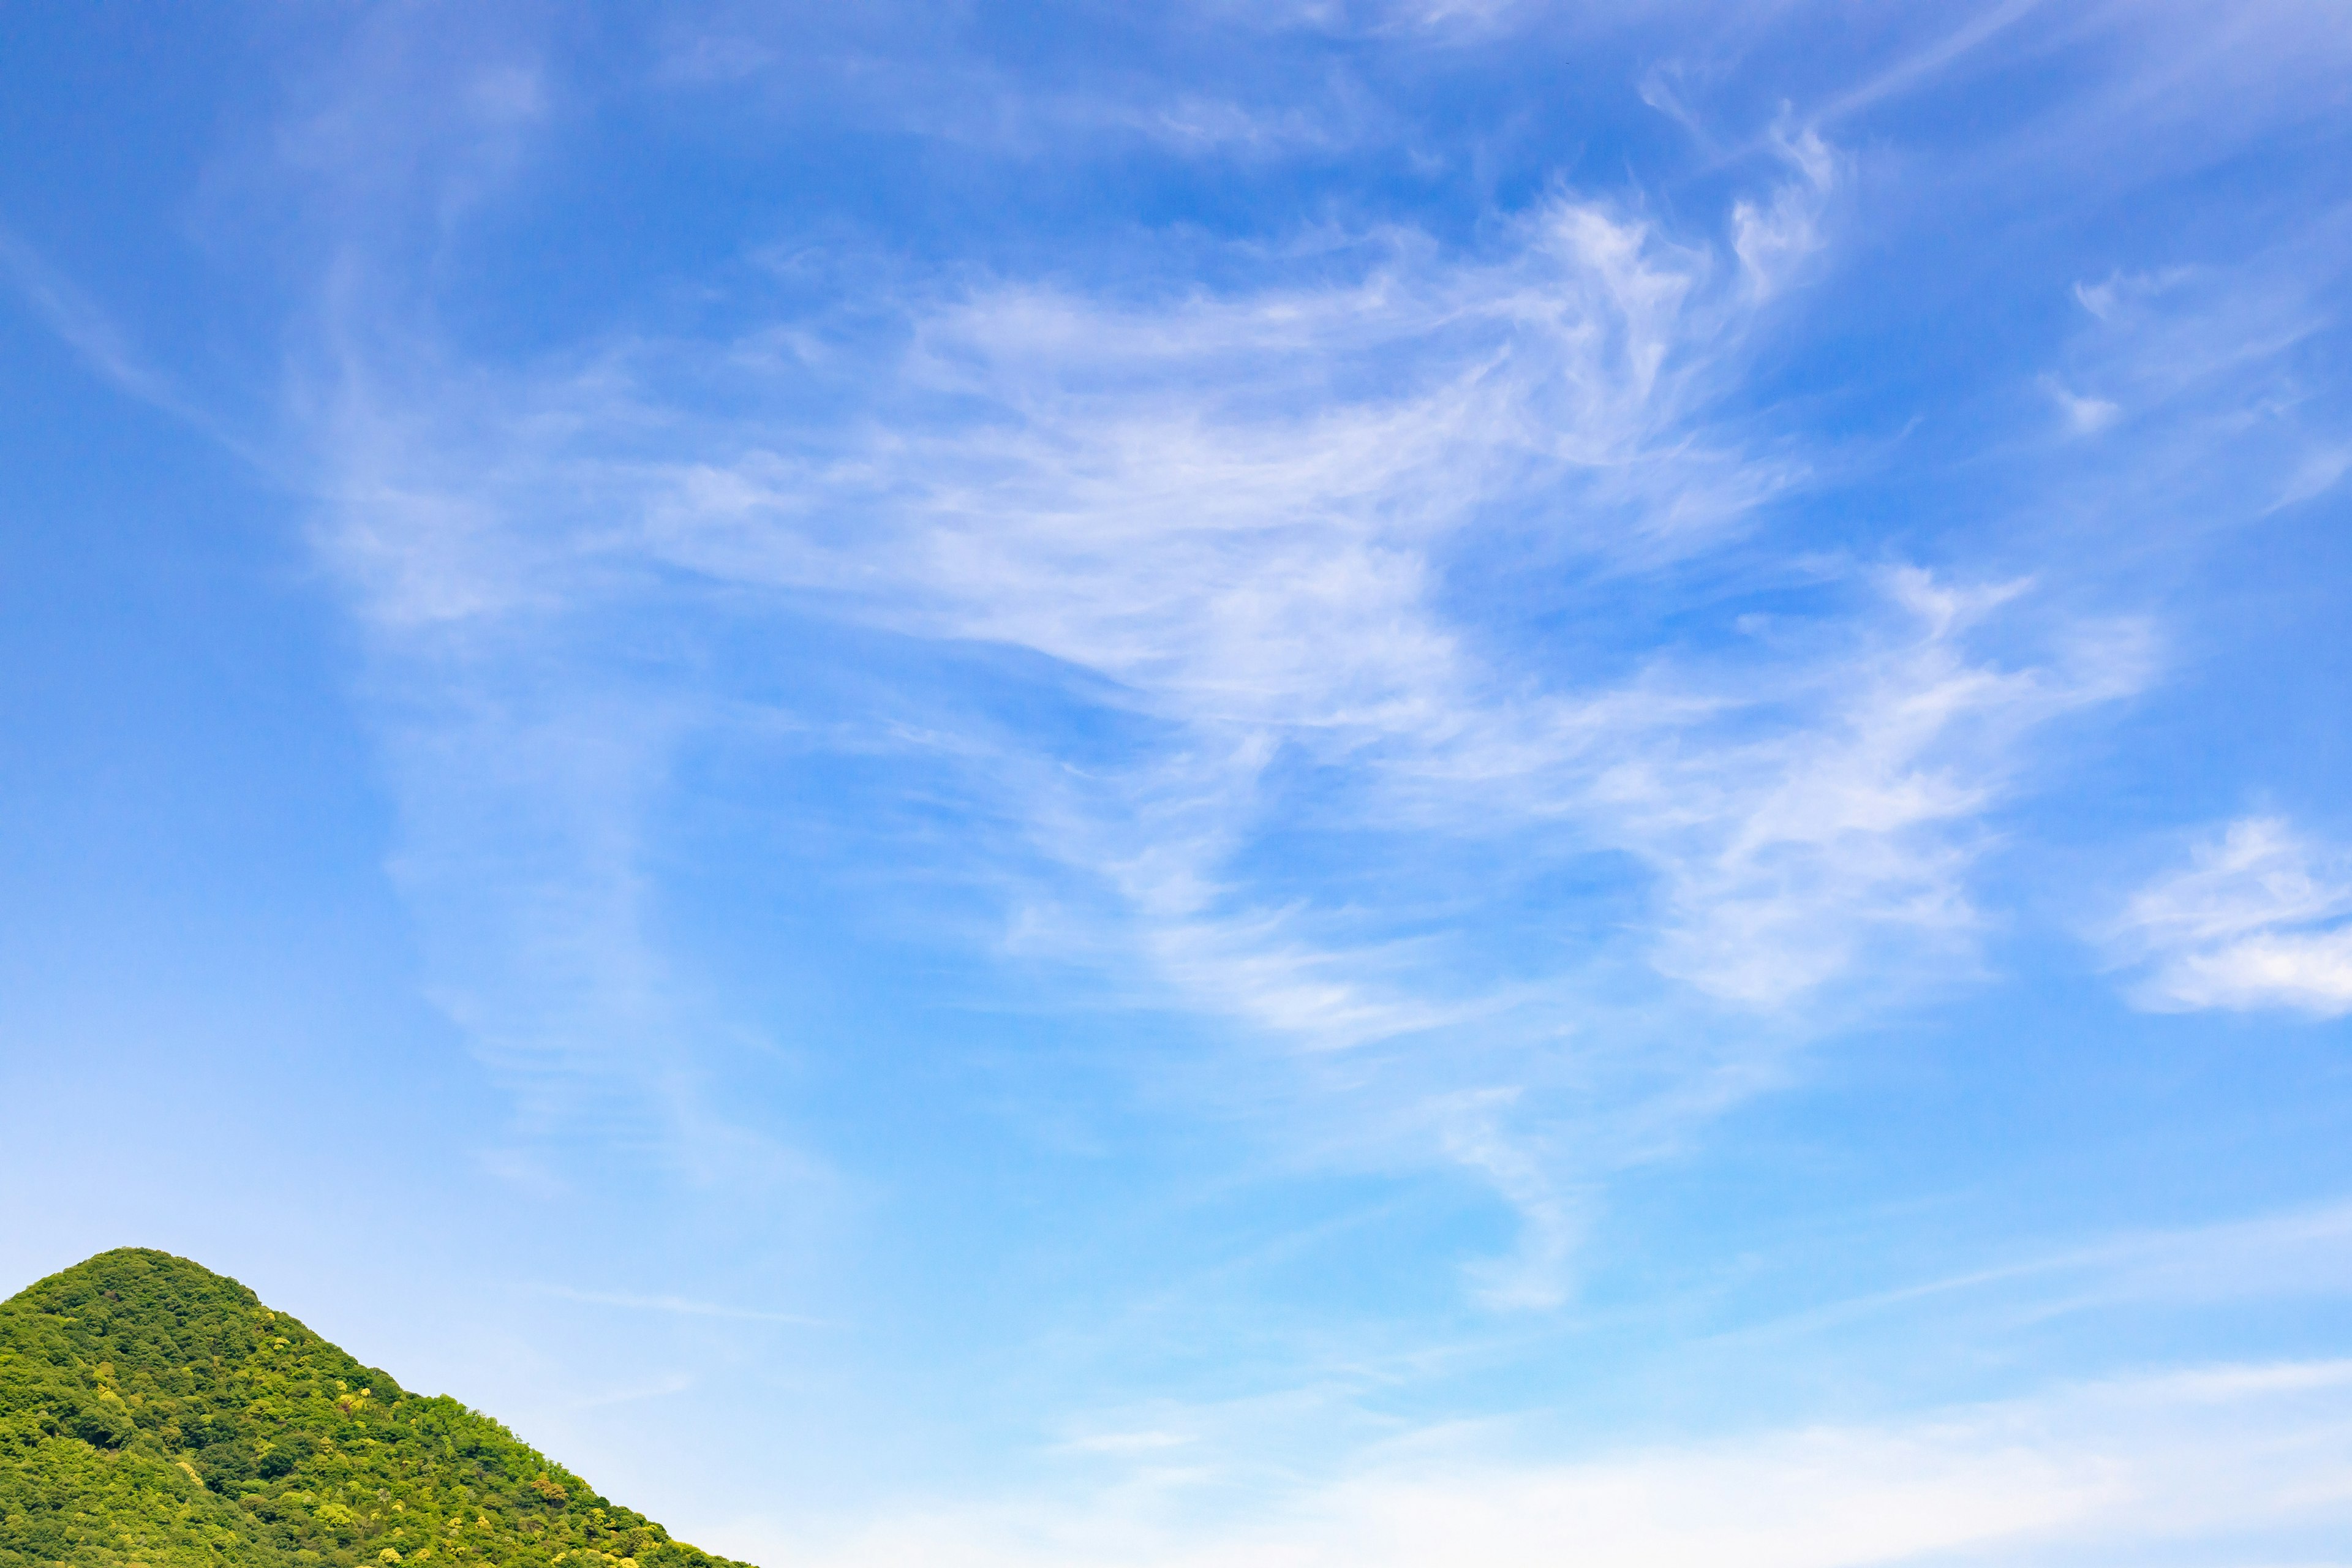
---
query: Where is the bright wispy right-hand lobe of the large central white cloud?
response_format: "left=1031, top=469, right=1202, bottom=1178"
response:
left=1595, top=571, right=2145, bottom=1006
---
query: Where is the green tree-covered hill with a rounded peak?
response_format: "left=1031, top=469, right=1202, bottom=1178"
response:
left=0, top=1248, right=743, bottom=1568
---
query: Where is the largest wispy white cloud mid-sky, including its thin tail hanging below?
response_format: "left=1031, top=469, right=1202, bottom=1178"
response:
left=564, top=211, right=2145, bottom=1307
